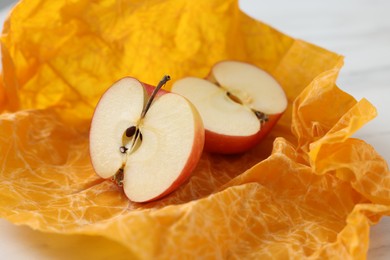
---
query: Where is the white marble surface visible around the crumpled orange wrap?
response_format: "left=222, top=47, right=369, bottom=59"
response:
left=0, top=0, right=390, bottom=260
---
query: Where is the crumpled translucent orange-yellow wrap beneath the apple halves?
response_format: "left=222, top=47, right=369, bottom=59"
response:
left=0, top=0, right=390, bottom=259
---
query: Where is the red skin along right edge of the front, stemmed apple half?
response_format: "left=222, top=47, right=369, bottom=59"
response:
left=145, top=104, right=205, bottom=202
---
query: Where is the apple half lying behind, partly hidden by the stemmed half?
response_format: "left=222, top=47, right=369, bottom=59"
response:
left=172, top=61, right=287, bottom=154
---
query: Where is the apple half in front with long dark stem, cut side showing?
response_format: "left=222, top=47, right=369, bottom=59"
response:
left=89, top=76, right=204, bottom=202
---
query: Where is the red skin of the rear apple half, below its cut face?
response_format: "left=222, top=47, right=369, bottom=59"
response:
left=204, top=113, right=283, bottom=154
